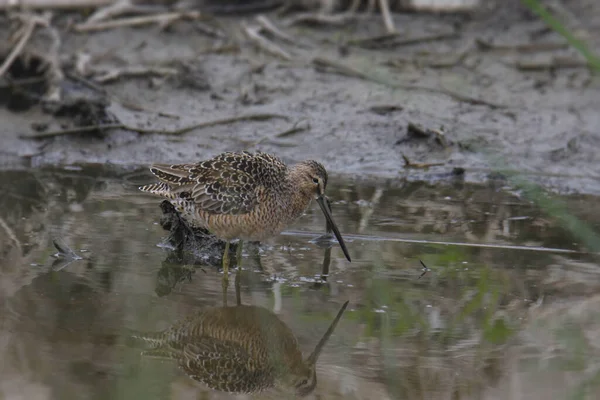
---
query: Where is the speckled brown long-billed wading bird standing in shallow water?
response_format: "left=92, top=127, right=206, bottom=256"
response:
left=140, top=152, right=351, bottom=276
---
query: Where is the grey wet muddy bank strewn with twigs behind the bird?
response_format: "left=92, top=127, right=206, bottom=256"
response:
left=0, top=1, right=600, bottom=194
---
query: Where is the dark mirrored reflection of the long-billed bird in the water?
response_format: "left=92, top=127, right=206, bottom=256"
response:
left=133, top=269, right=348, bottom=396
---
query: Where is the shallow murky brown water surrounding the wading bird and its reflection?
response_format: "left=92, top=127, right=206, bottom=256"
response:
left=0, top=166, right=600, bottom=399
